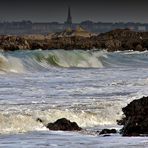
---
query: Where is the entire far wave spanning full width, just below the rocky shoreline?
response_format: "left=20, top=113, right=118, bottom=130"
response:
left=0, top=50, right=148, bottom=73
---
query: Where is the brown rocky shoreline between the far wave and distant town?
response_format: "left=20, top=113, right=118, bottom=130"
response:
left=0, top=29, right=148, bottom=52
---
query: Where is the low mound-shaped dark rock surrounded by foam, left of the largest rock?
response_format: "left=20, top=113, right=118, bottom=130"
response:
left=46, top=118, right=82, bottom=131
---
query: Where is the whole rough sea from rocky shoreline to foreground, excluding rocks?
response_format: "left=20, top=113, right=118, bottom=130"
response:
left=0, top=49, right=148, bottom=148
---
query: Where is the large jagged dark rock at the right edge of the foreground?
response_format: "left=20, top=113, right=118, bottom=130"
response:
left=118, top=97, right=148, bottom=136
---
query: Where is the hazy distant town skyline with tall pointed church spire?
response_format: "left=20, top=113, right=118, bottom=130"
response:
left=0, top=7, right=148, bottom=35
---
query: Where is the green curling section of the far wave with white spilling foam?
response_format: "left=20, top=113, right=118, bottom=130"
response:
left=34, top=50, right=103, bottom=68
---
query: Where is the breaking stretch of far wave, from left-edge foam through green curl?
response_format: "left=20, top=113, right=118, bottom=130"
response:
left=0, top=50, right=103, bottom=73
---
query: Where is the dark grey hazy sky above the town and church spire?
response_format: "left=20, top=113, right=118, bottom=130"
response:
left=0, top=0, right=148, bottom=23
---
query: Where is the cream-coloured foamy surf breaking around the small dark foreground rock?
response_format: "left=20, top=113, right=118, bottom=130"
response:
left=0, top=101, right=123, bottom=134
